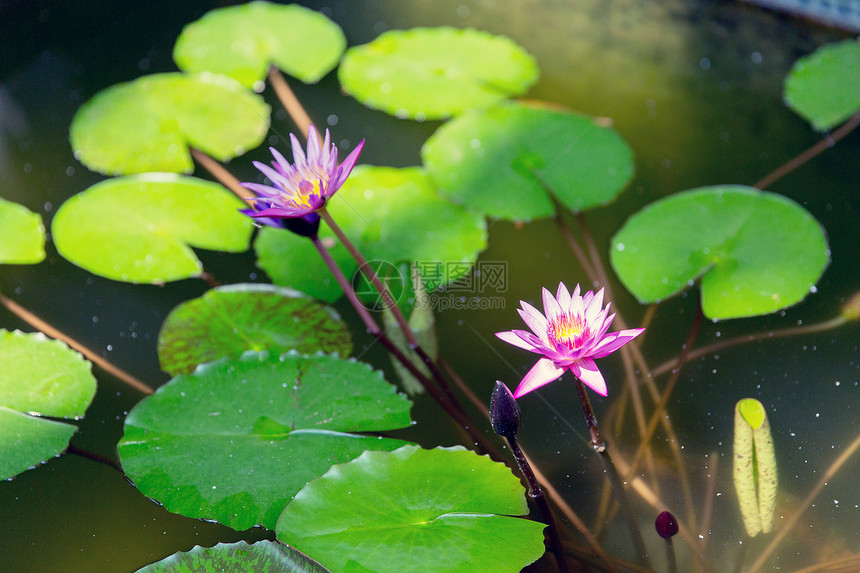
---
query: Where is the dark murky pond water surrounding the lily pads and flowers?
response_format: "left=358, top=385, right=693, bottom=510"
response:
left=0, top=0, right=860, bottom=572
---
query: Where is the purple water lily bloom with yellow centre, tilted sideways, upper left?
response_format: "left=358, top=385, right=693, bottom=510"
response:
left=242, top=126, right=364, bottom=220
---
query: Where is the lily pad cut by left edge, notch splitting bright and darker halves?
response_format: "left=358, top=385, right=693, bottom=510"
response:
left=0, top=329, right=96, bottom=479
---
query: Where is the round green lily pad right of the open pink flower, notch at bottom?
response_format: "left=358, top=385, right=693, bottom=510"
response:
left=610, top=185, right=829, bottom=319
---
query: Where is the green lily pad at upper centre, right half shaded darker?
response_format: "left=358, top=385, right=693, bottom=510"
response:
left=421, top=103, right=633, bottom=221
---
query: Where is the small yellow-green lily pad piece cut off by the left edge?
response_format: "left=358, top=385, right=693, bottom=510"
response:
left=0, top=199, right=45, bottom=265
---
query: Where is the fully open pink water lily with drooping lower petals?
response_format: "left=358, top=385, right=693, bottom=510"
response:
left=496, top=283, right=645, bottom=398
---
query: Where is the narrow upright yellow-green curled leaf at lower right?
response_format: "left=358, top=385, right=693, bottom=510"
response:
left=733, top=398, right=778, bottom=537
